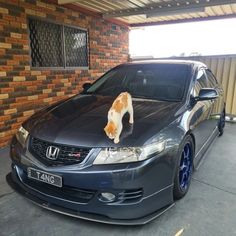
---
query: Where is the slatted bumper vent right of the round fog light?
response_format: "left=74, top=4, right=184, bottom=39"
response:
left=118, top=188, right=143, bottom=203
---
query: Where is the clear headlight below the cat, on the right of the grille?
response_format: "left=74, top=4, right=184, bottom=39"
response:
left=93, top=141, right=165, bottom=165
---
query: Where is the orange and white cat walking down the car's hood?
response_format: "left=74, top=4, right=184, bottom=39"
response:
left=104, top=92, right=134, bottom=143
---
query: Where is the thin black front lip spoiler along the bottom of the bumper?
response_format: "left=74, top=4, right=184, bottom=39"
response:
left=6, top=173, right=174, bottom=225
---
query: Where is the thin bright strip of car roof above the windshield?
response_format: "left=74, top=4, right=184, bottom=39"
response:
left=123, top=59, right=207, bottom=68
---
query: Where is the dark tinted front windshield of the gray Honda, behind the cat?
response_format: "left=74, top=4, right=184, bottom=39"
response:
left=85, top=64, right=190, bottom=101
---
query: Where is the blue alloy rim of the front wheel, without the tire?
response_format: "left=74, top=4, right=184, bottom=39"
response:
left=179, top=143, right=193, bottom=191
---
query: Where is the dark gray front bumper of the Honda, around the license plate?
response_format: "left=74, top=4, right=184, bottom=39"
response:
left=7, top=137, right=174, bottom=225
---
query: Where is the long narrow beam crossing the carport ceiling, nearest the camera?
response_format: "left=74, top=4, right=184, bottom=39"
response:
left=103, top=0, right=236, bottom=18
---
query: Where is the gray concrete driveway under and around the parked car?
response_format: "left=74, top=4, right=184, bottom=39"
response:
left=0, top=124, right=236, bottom=236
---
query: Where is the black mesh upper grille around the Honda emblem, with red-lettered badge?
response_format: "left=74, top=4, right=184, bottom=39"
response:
left=29, top=137, right=91, bottom=166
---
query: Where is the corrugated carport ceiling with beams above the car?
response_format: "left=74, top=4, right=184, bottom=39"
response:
left=58, top=0, right=236, bottom=26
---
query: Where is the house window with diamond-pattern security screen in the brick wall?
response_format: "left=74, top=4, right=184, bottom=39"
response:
left=29, top=18, right=88, bottom=68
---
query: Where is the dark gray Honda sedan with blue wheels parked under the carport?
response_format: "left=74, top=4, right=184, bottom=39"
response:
left=7, top=60, right=225, bottom=225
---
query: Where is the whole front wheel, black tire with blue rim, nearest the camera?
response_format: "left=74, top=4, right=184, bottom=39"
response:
left=173, top=135, right=194, bottom=200
